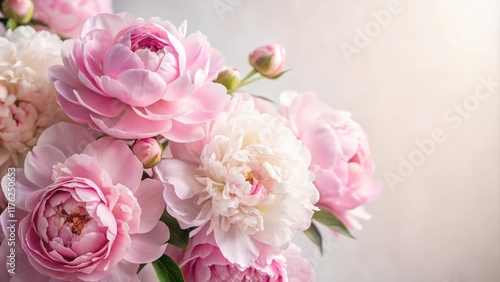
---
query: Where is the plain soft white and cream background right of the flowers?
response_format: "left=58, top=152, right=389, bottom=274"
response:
left=115, top=0, right=500, bottom=282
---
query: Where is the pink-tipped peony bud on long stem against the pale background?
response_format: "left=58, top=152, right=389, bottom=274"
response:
left=248, top=44, right=286, bottom=78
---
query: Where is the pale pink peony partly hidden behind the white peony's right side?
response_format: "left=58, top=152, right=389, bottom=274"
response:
left=280, top=92, right=380, bottom=229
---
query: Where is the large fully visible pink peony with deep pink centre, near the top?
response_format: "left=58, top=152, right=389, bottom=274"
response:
left=50, top=13, right=228, bottom=142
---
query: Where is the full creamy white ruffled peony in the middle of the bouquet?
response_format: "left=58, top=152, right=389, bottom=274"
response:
left=155, top=94, right=319, bottom=267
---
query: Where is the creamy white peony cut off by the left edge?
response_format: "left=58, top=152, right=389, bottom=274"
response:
left=0, top=26, right=64, bottom=170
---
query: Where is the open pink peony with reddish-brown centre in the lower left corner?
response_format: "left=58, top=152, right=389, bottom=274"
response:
left=0, top=123, right=169, bottom=281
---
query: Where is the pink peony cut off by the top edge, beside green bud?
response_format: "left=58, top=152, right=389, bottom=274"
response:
left=33, top=0, right=113, bottom=38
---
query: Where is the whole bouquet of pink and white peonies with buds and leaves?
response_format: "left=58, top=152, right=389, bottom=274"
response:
left=0, top=0, right=379, bottom=281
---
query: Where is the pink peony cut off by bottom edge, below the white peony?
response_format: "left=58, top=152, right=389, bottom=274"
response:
left=166, top=227, right=314, bottom=282
